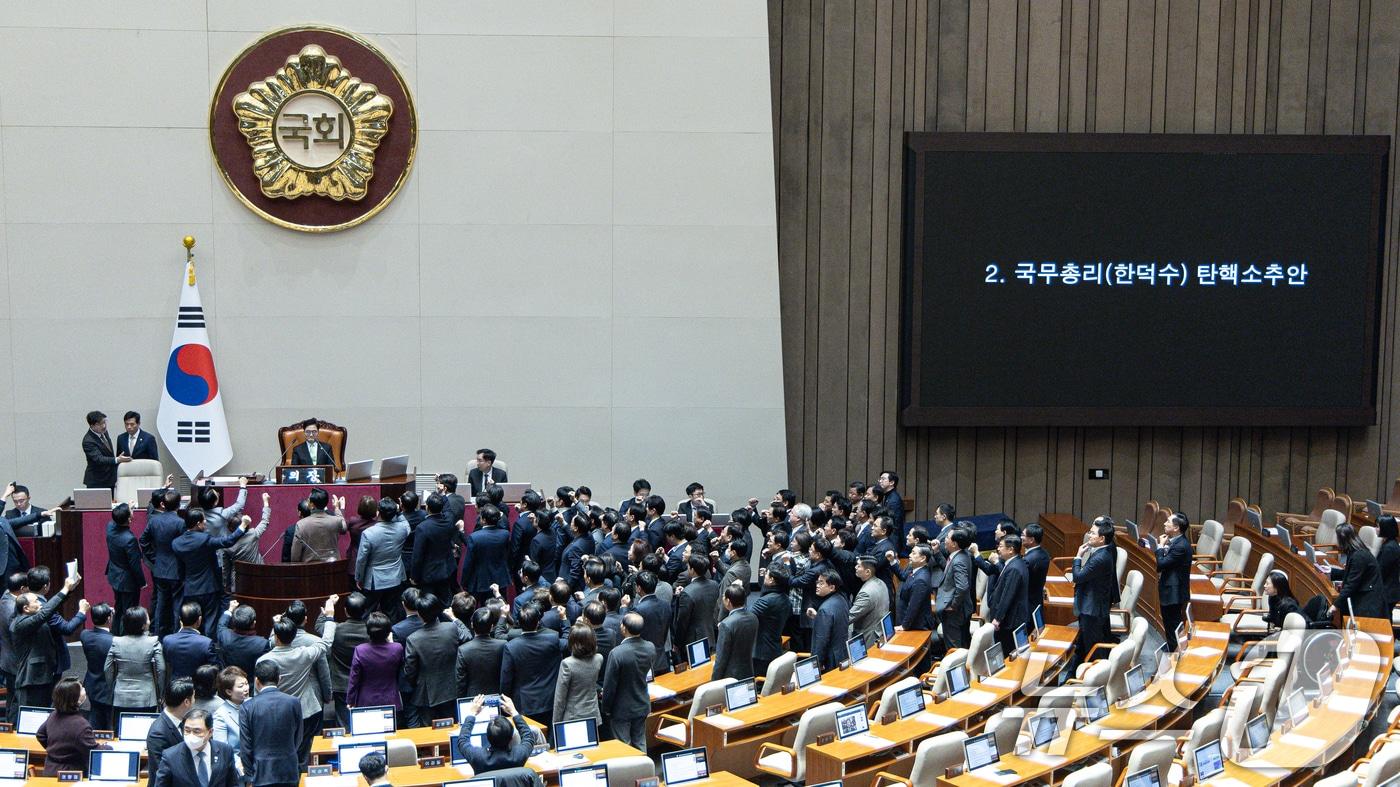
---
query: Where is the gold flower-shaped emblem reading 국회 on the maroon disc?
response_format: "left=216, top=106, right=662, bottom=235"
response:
left=234, top=43, right=393, bottom=200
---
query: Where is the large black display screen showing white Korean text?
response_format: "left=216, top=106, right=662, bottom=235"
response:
left=900, top=133, right=1389, bottom=426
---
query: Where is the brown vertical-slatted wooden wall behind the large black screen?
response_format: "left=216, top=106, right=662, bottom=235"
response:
left=769, top=0, right=1400, bottom=522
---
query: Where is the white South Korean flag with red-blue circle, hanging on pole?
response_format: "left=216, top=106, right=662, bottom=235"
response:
left=155, top=260, right=234, bottom=478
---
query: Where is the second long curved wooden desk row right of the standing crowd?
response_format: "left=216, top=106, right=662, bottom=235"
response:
left=806, top=626, right=1074, bottom=787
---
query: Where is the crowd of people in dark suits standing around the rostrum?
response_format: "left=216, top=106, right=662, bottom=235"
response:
left=0, top=451, right=1215, bottom=786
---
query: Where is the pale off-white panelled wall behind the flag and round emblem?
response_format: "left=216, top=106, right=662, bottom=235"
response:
left=0, top=0, right=787, bottom=507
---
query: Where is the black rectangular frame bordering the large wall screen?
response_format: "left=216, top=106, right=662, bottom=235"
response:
left=899, top=132, right=1390, bottom=427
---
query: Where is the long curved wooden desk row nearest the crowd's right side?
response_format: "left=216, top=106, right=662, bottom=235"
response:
left=690, top=632, right=928, bottom=781
